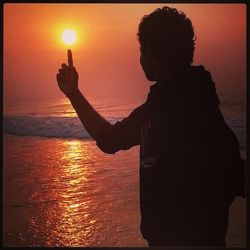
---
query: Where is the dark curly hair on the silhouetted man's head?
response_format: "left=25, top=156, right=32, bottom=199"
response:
left=137, top=6, right=196, bottom=66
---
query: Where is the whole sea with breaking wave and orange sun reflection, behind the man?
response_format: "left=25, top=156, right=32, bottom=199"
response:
left=3, top=90, right=246, bottom=247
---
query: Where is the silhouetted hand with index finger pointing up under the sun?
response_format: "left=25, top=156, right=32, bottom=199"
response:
left=56, top=50, right=78, bottom=96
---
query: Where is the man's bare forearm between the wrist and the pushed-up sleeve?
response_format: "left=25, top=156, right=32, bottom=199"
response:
left=68, top=90, right=109, bottom=140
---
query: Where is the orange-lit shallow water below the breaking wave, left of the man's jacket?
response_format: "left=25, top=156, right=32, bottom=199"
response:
left=4, top=137, right=146, bottom=247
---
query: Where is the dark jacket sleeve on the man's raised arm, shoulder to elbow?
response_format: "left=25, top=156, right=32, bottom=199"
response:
left=96, top=105, right=144, bottom=154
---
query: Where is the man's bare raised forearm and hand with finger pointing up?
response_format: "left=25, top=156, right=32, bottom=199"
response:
left=56, top=50, right=109, bottom=140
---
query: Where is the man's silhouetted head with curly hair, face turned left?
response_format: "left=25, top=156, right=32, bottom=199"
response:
left=137, top=7, right=195, bottom=81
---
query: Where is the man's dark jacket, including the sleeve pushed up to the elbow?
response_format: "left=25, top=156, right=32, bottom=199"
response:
left=97, top=66, right=244, bottom=239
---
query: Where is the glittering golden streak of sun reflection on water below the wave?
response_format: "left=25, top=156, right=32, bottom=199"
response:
left=47, top=140, right=96, bottom=246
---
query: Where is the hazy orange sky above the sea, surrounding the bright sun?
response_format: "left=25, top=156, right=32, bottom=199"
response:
left=4, top=3, right=246, bottom=98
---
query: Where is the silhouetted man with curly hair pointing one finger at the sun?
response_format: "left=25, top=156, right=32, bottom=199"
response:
left=57, top=7, right=244, bottom=246
